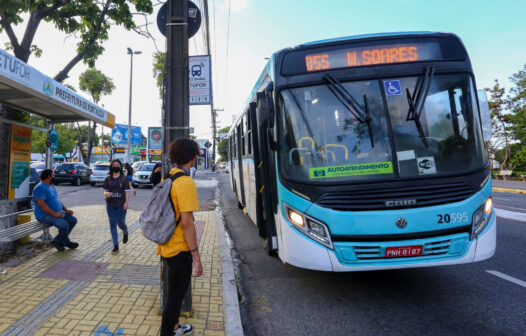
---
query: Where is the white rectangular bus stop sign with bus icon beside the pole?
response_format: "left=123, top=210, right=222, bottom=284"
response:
left=188, top=55, right=212, bottom=105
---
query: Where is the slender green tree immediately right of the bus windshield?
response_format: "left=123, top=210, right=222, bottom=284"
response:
left=485, top=79, right=511, bottom=170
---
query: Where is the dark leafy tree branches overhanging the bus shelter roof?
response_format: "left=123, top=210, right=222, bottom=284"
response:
left=0, top=0, right=153, bottom=81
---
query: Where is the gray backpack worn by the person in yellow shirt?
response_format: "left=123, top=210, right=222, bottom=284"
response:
left=139, top=172, right=186, bottom=244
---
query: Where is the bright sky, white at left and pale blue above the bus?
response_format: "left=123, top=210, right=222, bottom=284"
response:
left=0, top=0, right=526, bottom=144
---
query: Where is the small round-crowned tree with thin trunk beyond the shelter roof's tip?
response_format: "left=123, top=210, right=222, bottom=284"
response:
left=79, top=68, right=115, bottom=164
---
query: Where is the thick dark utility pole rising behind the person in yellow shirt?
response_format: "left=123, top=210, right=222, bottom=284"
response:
left=163, top=0, right=189, bottom=173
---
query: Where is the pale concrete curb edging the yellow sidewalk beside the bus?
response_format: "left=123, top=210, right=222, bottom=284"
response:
left=215, top=188, right=244, bottom=336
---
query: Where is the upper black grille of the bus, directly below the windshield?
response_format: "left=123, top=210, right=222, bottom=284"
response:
left=317, top=182, right=476, bottom=211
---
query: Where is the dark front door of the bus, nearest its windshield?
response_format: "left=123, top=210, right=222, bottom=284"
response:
left=256, top=86, right=278, bottom=254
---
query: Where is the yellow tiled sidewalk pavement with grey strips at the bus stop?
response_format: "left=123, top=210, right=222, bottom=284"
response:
left=0, top=206, right=226, bottom=336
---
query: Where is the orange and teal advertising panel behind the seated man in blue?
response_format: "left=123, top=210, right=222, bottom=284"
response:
left=8, top=125, right=31, bottom=199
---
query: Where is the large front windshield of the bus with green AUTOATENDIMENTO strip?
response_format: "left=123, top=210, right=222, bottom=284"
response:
left=279, top=75, right=487, bottom=182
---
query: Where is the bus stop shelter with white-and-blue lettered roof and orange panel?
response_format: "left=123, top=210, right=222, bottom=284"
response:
left=0, top=50, right=115, bottom=226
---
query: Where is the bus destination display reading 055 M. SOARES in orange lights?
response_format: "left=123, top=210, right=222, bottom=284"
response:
left=305, top=43, right=442, bottom=72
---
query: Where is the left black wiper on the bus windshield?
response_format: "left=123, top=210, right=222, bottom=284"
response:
left=323, top=75, right=374, bottom=147
